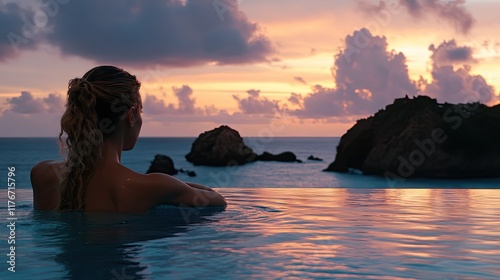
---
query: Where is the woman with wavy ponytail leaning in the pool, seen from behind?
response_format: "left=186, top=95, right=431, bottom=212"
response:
left=31, top=66, right=226, bottom=212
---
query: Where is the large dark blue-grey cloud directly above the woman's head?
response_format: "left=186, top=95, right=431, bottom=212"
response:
left=38, top=0, right=274, bottom=66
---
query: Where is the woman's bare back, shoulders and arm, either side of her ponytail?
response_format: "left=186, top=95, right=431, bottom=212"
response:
left=31, top=160, right=226, bottom=213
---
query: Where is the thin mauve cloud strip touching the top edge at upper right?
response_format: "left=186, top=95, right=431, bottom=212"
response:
left=358, top=0, right=474, bottom=34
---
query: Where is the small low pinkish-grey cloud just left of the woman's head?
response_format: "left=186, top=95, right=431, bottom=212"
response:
left=7, top=91, right=64, bottom=114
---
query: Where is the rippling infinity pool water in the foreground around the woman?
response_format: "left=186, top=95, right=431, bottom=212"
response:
left=0, top=188, right=500, bottom=280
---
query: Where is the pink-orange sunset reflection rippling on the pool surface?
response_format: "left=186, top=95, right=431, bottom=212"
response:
left=223, top=188, right=500, bottom=279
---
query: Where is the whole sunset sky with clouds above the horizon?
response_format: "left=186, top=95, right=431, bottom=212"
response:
left=0, top=0, right=500, bottom=138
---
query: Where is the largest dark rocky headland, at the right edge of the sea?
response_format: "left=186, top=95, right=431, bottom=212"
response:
left=325, top=96, right=500, bottom=178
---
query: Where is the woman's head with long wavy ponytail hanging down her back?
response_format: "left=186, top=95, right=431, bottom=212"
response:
left=59, top=66, right=142, bottom=210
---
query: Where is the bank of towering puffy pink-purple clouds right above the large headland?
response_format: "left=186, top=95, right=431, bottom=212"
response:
left=288, top=29, right=498, bottom=119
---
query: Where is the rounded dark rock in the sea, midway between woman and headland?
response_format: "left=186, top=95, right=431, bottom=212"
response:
left=186, top=125, right=257, bottom=166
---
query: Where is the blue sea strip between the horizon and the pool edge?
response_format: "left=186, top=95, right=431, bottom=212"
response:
left=0, top=137, right=500, bottom=189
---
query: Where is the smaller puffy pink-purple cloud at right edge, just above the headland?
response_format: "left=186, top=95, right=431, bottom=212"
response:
left=424, top=40, right=498, bottom=103
